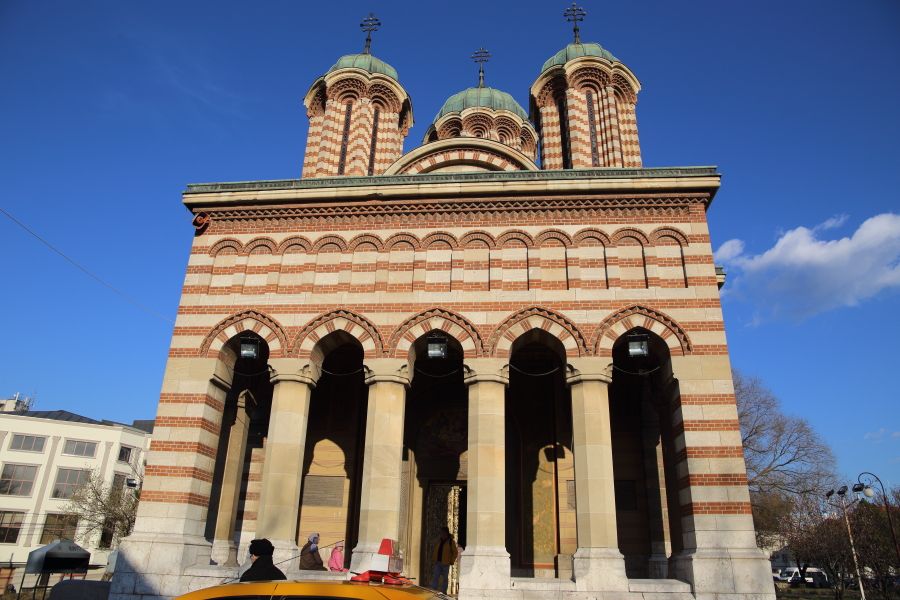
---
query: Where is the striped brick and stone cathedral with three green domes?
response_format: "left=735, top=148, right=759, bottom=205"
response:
left=112, top=5, right=775, bottom=600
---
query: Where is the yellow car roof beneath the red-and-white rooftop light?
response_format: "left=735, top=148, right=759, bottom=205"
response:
left=176, top=581, right=446, bottom=600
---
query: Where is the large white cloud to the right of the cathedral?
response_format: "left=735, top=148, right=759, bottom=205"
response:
left=715, top=213, right=900, bottom=318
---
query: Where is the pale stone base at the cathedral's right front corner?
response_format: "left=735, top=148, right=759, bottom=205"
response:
left=673, top=549, right=775, bottom=600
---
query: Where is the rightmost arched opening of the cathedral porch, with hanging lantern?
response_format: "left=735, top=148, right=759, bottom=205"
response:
left=610, top=327, right=681, bottom=578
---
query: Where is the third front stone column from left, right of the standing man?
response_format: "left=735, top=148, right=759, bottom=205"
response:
left=459, top=359, right=510, bottom=595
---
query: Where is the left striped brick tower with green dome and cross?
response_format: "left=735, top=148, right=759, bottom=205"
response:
left=303, top=14, right=413, bottom=178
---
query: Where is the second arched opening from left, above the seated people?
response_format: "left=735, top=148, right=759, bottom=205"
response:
left=297, top=331, right=368, bottom=567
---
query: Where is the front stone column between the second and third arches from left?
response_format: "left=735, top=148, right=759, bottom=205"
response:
left=350, top=359, right=409, bottom=573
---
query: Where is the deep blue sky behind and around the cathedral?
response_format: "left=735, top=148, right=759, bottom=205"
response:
left=0, top=0, right=900, bottom=485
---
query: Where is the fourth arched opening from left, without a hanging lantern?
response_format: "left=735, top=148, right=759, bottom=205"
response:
left=506, top=329, right=577, bottom=578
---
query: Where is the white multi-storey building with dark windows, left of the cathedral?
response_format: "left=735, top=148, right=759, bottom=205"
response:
left=0, top=403, right=153, bottom=589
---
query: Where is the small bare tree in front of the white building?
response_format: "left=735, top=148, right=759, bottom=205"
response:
left=64, top=465, right=142, bottom=548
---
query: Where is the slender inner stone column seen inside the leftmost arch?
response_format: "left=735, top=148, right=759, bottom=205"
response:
left=212, top=390, right=256, bottom=567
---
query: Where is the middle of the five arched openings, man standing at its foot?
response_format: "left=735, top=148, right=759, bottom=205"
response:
left=400, top=330, right=468, bottom=593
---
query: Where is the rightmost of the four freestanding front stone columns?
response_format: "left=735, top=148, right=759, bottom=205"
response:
left=567, top=359, right=628, bottom=591
